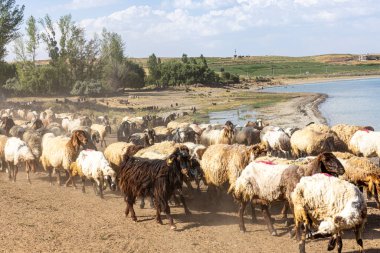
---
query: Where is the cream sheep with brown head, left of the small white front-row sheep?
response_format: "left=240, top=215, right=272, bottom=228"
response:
left=40, top=130, right=88, bottom=186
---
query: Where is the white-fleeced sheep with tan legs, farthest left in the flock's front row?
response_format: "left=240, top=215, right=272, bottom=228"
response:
left=4, top=137, right=36, bottom=183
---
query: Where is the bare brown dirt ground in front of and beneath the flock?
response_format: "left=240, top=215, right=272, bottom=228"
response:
left=0, top=136, right=380, bottom=253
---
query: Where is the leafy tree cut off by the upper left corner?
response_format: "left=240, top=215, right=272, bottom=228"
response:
left=0, top=0, right=25, bottom=61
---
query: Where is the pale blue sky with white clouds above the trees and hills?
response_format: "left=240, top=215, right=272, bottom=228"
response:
left=7, top=0, right=380, bottom=60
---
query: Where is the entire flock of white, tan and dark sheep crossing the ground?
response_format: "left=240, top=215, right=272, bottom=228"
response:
left=0, top=109, right=380, bottom=252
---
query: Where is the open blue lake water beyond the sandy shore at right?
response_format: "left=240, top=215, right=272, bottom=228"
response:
left=264, top=79, right=380, bottom=129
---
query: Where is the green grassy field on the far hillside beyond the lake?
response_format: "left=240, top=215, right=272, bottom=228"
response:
left=133, top=54, right=380, bottom=78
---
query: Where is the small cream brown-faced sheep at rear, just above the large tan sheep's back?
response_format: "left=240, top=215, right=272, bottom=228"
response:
left=200, top=126, right=234, bottom=146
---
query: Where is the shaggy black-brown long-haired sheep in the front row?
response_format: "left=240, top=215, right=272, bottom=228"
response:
left=119, top=148, right=190, bottom=230
